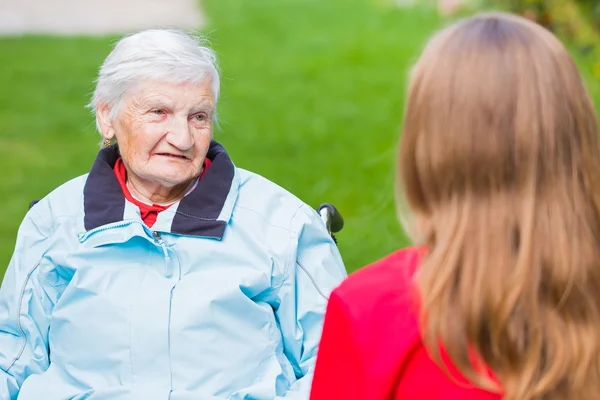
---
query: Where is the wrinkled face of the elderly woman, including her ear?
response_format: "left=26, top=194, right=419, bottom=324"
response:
left=99, top=80, right=215, bottom=190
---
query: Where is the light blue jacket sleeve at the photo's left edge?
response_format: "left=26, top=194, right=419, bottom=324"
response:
left=0, top=207, right=50, bottom=400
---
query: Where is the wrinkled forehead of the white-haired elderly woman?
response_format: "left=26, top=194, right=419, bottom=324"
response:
left=128, top=80, right=214, bottom=107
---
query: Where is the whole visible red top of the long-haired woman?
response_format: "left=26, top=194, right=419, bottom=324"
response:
left=310, top=248, right=502, bottom=400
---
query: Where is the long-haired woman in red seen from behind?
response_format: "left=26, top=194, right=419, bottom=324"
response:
left=311, top=10, right=600, bottom=400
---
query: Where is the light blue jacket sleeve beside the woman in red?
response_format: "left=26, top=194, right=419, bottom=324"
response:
left=276, top=206, right=347, bottom=400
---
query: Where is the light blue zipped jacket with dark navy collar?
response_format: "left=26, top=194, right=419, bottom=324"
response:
left=0, top=142, right=346, bottom=400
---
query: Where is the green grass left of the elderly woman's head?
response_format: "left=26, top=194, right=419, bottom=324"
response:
left=0, top=37, right=119, bottom=268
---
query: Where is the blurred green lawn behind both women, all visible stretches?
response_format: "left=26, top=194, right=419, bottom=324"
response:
left=0, top=0, right=600, bottom=276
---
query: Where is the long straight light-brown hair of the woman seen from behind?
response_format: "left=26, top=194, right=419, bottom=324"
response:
left=399, top=13, right=600, bottom=400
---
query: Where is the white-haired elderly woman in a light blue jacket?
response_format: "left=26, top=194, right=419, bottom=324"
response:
left=0, top=30, right=345, bottom=400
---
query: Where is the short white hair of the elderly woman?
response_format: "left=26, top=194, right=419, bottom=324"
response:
left=89, top=29, right=220, bottom=134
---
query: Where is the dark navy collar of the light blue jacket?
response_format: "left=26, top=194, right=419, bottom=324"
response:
left=83, top=141, right=237, bottom=239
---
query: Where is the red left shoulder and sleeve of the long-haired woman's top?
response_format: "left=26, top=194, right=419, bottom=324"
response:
left=311, top=249, right=420, bottom=400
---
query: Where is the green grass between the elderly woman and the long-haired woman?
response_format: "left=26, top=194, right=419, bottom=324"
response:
left=204, top=0, right=438, bottom=271
